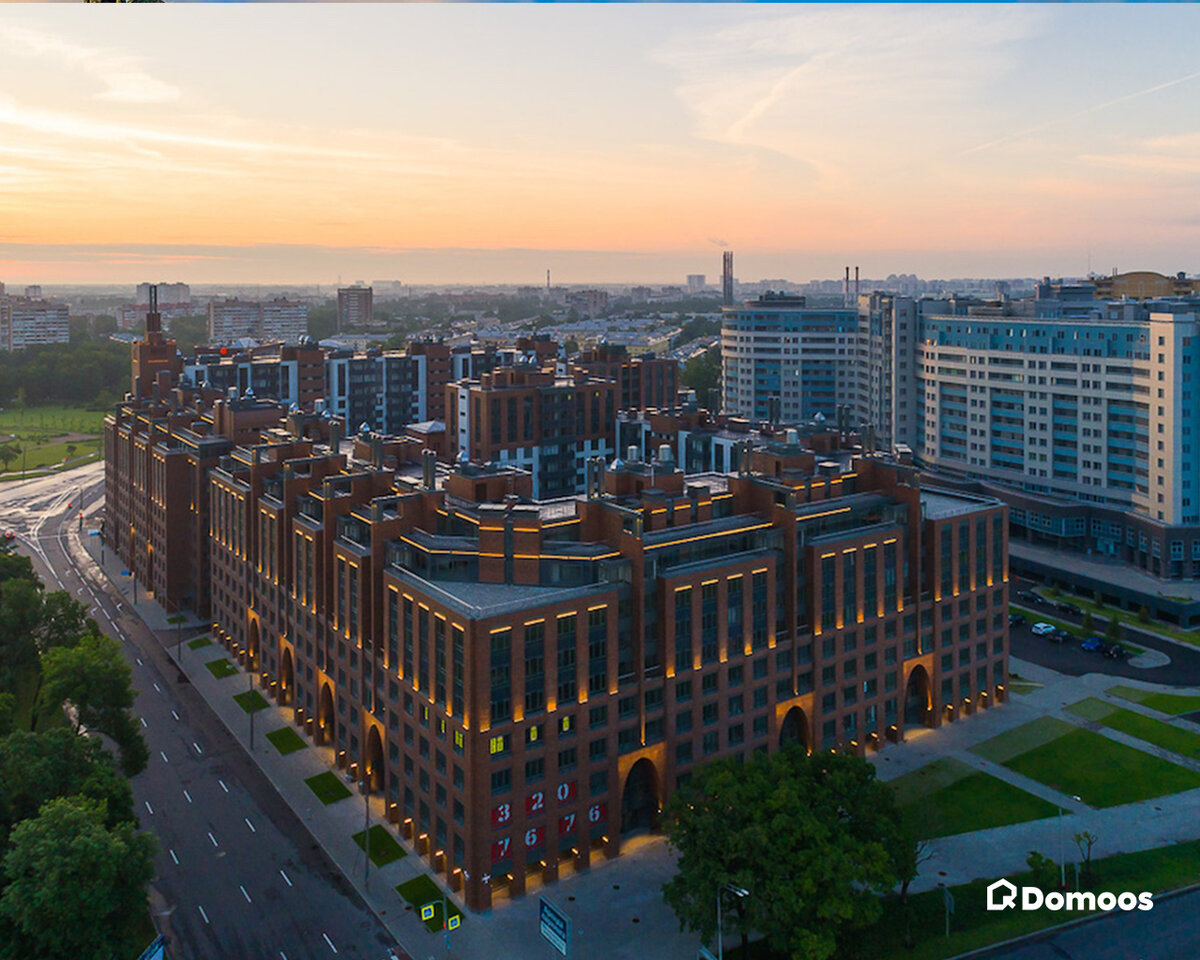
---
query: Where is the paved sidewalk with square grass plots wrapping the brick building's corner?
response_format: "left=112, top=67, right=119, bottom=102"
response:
left=68, top=523, right=700, bottom=960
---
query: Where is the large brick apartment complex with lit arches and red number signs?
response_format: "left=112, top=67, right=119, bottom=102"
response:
left=106, top=312, right=1008, bottom=910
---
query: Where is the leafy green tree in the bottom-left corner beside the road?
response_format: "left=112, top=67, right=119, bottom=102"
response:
left=0, top=797, right=155, bottom=960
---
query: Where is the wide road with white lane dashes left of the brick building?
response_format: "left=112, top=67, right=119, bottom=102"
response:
left=0, top=464, right=403, bottom=960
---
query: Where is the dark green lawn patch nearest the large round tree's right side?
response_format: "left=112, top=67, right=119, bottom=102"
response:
left=890, top=757, right=1057, bottom=840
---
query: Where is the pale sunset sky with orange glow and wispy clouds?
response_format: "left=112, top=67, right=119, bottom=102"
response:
left=0, top=4, right=1200, bottom=284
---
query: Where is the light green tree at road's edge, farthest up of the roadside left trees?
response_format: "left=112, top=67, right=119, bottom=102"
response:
left=42, top=634, right=145, bottom=776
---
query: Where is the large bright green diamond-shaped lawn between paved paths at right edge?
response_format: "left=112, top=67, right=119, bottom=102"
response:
left=1003, top=727, right=1200, bottom=808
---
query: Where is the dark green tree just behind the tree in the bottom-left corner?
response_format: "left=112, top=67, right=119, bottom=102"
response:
left=0, top=727, right=133, bottom=844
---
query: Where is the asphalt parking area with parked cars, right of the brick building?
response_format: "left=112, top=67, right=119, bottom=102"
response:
left=1009, top=580, right=1200, bottom=691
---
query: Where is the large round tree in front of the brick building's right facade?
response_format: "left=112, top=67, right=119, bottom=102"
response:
left=662, top=746, right=902, bottom=960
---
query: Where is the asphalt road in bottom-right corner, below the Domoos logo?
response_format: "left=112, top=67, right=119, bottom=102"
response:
left=986, top=890, right=1200, bottom=960
